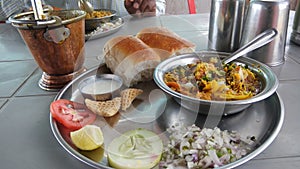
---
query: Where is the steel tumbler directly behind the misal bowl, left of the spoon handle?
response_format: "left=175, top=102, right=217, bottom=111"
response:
left=208, top=0, right=245, bottom=52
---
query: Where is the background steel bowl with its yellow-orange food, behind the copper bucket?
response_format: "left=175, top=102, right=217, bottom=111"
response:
left=85, top=9, right=117, bottom=32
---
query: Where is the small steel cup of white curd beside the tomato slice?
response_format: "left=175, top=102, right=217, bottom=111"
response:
left=78, top=74, right=123, bottom=101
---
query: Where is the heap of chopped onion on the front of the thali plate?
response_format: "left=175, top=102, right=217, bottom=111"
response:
left=159, top=123, right=255, bottom=168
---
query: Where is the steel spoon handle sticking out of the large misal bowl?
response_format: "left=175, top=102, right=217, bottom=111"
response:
left=222, top=28, right=278, bottom=64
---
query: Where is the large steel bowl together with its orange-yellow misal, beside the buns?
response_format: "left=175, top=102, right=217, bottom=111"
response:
left=153, top=51, right=279, bottom=115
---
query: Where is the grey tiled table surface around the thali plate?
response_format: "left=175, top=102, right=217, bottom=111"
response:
left=0, top=12, right=300, bottom=169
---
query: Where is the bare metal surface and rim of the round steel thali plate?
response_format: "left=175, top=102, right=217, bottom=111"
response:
left=50, top=65, right=284, bottom=168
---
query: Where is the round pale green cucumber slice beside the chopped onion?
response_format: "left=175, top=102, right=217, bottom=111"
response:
left=107, top=128, right=163, bottom=169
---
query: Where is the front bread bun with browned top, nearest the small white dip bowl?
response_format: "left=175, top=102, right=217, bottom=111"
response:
left=104, top=35, right=160, bottom=86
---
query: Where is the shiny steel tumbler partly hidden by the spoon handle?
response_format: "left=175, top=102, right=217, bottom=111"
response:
left=240, top=0, right=290, bottom=66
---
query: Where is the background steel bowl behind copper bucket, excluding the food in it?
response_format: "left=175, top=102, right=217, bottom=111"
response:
left=85, top=9, right=117, bottom=31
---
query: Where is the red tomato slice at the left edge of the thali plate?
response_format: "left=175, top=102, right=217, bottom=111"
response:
left=50, top=99, right=97, bottom=130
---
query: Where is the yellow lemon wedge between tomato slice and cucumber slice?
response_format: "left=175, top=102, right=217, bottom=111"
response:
left=70, top=125, right=104, bottom=150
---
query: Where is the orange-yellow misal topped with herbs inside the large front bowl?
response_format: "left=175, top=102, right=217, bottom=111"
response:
left=164, top=58, right=261, bottom=100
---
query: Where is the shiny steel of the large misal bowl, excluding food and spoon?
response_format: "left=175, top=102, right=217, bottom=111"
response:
left=153, top=51, right=279, bottom=115
